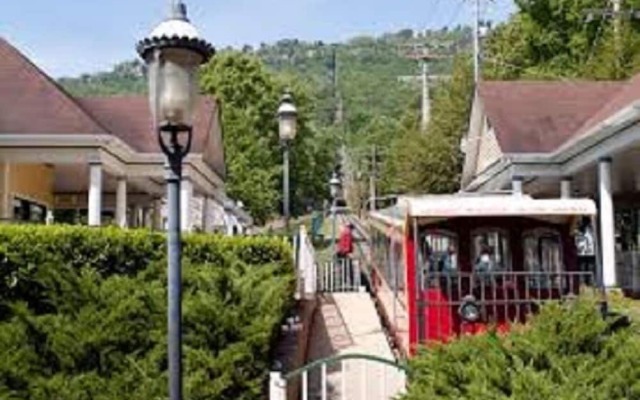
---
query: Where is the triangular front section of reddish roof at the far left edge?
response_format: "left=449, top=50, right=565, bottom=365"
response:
left=0, top=37, right=107, bottom=134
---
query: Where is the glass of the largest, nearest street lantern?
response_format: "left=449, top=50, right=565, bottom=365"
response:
left=148, top=48, right=203, bottom=126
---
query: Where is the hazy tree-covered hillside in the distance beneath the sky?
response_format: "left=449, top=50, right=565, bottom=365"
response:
left=60, top=27, right=471, bottom=131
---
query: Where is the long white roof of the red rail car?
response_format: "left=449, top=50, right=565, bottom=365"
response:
left=371, top=194, right=597, bottom=226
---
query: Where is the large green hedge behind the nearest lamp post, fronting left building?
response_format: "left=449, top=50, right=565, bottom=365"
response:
left=0, top=226, right=294, bottom=400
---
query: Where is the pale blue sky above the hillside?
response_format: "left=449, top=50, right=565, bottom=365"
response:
left=0, top=0, right=513, bottom=78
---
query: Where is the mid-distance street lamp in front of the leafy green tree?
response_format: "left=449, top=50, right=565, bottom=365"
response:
left=278, top=92, right=298, bottom=231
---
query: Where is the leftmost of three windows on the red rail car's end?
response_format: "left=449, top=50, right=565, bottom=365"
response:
left=420, top=231, right=458, bottom=273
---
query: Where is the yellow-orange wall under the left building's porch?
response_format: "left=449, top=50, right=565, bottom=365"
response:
left=7, top=164, right=54, bottom=207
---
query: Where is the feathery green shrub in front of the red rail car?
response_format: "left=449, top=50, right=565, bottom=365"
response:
left=403, top=299, right=640, bottom=400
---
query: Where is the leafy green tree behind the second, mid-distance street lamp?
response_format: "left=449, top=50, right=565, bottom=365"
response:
left=202, top=52, right=335, bottom=222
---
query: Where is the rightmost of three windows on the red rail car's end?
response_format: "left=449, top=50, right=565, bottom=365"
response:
left=523, top=229, right=564, bottom=287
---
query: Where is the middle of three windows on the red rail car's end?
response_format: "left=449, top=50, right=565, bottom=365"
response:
left=471, top=228, right=511, bottom=272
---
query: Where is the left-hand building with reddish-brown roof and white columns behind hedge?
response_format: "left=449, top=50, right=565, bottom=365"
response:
left=0, top=38, right=251, bottom=231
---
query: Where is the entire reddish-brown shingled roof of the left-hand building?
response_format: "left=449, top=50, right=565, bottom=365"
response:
left=0, top=37, right=225, bottom=177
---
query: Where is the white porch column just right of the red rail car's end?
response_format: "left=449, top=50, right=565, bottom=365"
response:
left=598, top=158, right=616, bottom=288
